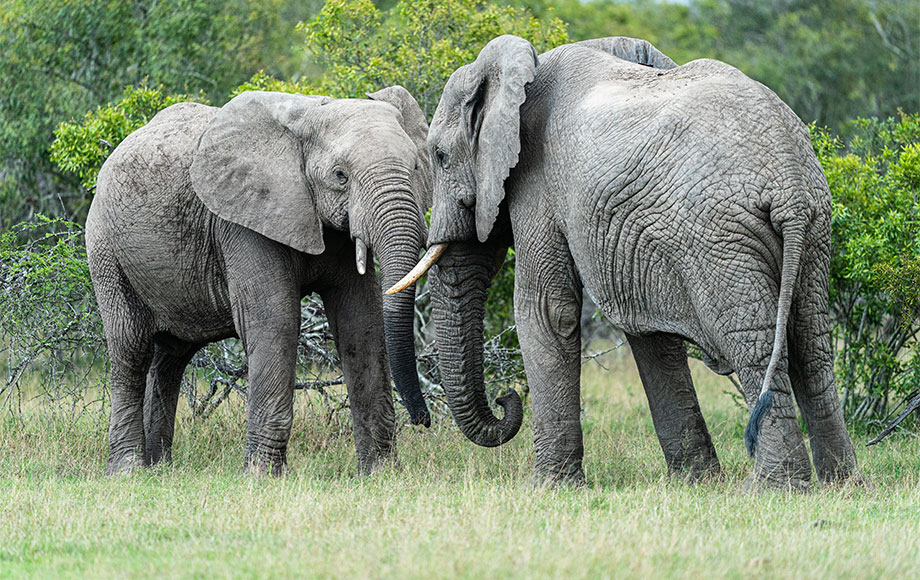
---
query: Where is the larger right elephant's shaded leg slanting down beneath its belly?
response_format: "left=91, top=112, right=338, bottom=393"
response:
left=627, top=333, right=721, bottom=480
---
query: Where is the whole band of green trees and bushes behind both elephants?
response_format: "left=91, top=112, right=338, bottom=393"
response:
left=0, top=0, right=920, bottom=424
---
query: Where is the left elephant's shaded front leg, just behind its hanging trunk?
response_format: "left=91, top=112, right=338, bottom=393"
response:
left=320, top=272, right=396, bottom=475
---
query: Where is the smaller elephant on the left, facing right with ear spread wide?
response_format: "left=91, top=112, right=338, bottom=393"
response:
left=86, top=87, right=431, bottom=475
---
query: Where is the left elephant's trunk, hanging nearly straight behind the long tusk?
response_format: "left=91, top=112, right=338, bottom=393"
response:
left=370, top=184, right=431, bottom=427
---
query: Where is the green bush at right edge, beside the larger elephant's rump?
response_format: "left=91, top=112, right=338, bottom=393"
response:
left=812, top=114, right=920, bottom=423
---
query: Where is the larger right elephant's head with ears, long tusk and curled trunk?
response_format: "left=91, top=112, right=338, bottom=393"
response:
left=391, top=36, right=676, bottom=447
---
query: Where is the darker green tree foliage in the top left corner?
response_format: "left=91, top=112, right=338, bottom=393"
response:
left=0, top=0, right=318, bottom=227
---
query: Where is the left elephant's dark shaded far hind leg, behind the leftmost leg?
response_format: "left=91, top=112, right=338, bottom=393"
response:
left=144, top=344, right=200, bottom=465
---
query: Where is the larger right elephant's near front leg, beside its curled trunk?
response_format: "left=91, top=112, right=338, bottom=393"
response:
left=514, top=239, right=585, bottom=485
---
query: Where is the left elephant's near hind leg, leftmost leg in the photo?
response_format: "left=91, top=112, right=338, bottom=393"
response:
left=89, top=251, right=153, bottom=474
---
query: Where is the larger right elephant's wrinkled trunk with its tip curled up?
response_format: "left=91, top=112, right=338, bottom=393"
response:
left=429, top=243, right=524, bottom=447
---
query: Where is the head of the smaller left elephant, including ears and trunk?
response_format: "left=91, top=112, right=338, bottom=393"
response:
left=191, top=87, right=431, bottom=425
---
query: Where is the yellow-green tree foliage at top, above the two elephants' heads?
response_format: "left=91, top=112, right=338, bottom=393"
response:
left=300, top=0, right=568, bottom=118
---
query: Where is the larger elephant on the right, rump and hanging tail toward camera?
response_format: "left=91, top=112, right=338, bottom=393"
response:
left=428, top=36, right=857, bottom=488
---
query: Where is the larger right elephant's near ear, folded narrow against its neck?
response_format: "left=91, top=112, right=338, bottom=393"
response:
left=468, top=35, right=539, bottom=242
